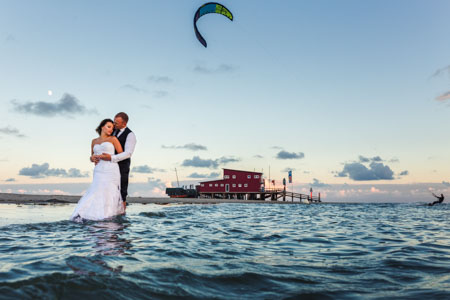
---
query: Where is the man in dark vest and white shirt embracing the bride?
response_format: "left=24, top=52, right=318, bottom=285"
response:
left=99, top=112, right=136, bottom=210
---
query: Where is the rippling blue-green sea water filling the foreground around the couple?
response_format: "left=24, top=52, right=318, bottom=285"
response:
left=0, top=203, right=450, bottom=299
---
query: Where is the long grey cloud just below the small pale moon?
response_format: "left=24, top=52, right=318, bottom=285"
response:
left=11, top=94, right=96, bottom=117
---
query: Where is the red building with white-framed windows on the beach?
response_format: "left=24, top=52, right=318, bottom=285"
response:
left=197, top=169, right=264, bottom=199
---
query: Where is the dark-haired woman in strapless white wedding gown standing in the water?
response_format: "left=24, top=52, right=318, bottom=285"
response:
left=70, top=119, right=125, bottom=222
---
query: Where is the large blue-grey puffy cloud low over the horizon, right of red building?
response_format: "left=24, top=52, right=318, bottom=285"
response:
left=337, top=161, right=394, bottom=181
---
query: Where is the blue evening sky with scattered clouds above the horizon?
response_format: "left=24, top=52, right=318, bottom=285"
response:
left=0, top=0, right=450, bottom=201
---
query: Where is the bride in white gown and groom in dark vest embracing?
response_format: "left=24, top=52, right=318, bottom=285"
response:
left=70, top=112, right=136, bottom=222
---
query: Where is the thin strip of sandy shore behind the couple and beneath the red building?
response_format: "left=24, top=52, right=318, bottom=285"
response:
left=0, top=193, right=306, bottom=205
